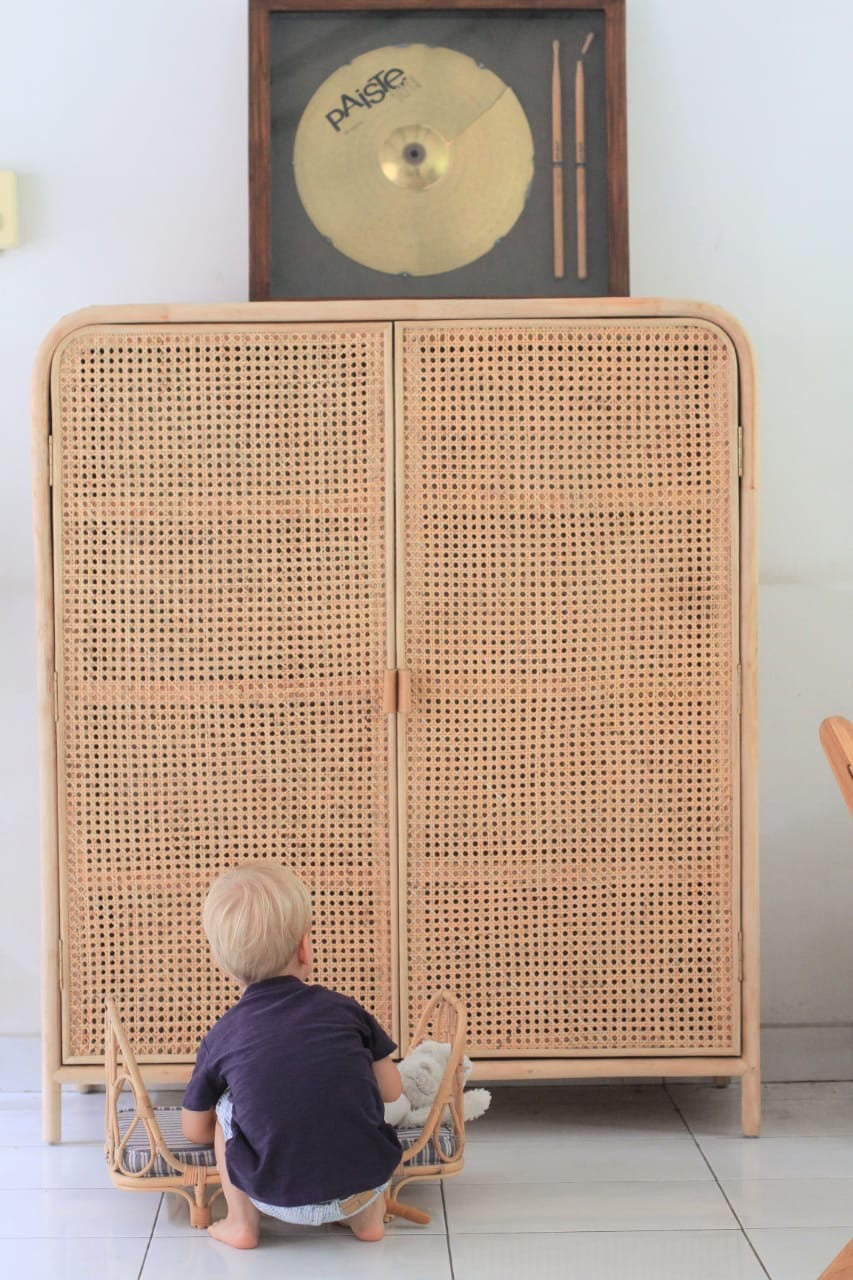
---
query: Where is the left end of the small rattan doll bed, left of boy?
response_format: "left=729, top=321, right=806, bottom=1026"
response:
left=104, top=996, right=222, bottom=1228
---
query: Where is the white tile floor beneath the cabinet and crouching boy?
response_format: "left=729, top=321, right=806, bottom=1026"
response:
left=0, top=1042, right=853, bottom=1280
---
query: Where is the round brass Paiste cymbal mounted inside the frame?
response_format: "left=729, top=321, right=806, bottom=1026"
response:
left=293, top=45, right=533, bottom=275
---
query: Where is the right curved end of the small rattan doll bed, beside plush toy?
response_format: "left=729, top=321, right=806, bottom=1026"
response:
left=386, top=991, right=465, bottom=1224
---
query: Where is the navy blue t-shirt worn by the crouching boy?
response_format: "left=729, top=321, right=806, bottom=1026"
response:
left=183, top=975, right=401, bottom=1207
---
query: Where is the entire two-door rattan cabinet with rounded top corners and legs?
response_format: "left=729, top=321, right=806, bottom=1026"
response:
left=35, top=300, right=758, bottom=1140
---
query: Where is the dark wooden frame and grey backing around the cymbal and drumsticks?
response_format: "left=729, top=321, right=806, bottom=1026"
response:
left=248, top=0, right=629, bottom=301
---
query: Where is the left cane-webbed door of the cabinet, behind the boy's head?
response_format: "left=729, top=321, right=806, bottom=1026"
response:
left=53, top=325, right=392, bottom=1061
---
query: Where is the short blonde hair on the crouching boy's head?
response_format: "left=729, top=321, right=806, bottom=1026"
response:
left=204, top=861, right=311, bottom=987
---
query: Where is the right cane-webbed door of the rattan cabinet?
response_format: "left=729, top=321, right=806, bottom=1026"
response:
left=398, top=319, right=739, bottom=1056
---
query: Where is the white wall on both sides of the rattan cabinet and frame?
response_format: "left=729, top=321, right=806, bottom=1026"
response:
left=0, top=0, right=853, bottom=1078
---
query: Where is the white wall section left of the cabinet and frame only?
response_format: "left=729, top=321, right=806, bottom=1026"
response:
left=0, top=0, right=248, bottom=1033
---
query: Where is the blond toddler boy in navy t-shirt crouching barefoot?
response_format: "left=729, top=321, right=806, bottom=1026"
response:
left=182, top=861, right=402, bottom=1249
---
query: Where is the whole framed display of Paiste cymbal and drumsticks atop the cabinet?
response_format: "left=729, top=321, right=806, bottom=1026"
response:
left=248, top=0, right=629, bottom=301
